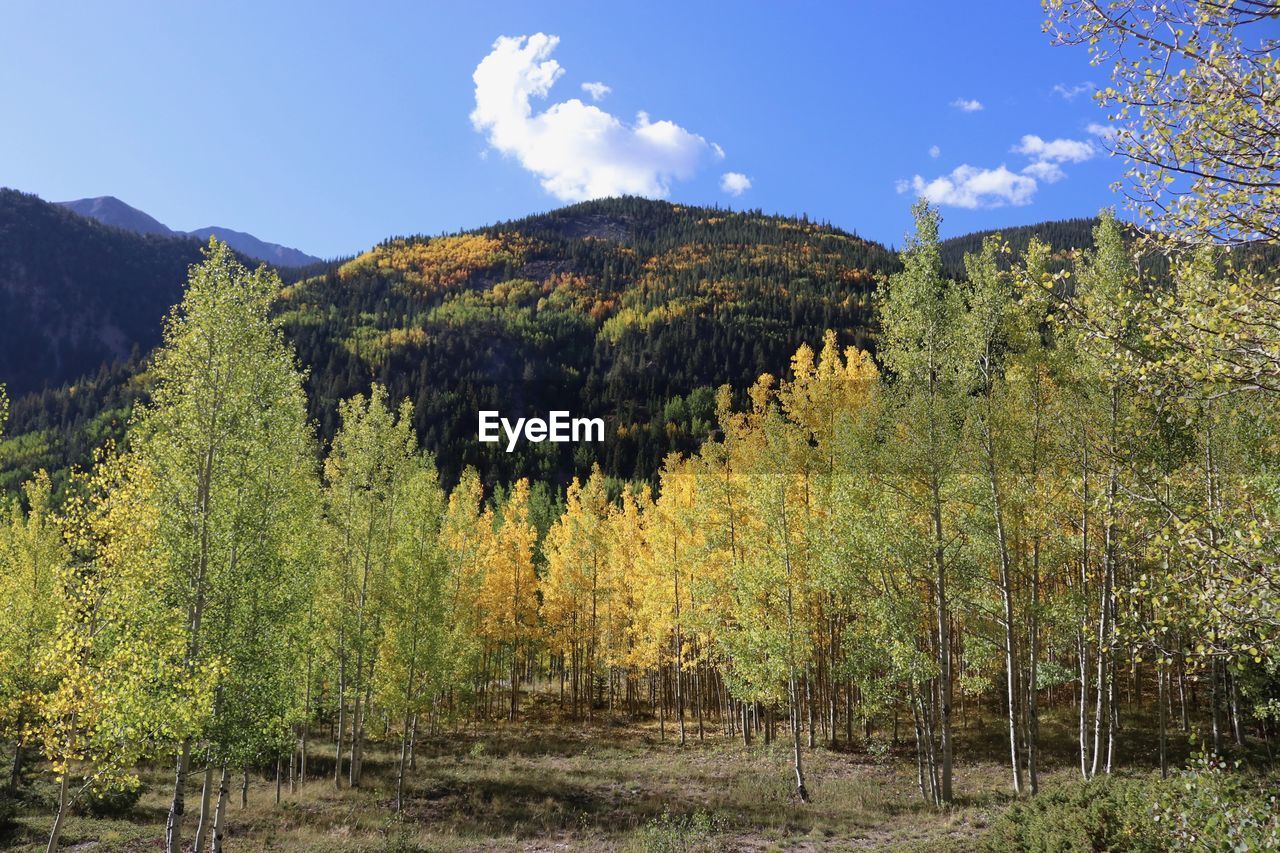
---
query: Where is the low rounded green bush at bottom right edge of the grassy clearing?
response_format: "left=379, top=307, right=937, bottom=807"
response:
left=988, top=776, right=1169, bottom=853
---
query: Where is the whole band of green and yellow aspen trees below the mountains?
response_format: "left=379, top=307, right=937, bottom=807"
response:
left=0, top=189, right=1280, bottom=853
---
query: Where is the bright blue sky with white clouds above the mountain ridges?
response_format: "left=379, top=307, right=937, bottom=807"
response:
left=0, top=0, right=1121, bottom=256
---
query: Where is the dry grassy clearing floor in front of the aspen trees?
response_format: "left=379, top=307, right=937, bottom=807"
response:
left=0, top=691, right=1198, bottom=852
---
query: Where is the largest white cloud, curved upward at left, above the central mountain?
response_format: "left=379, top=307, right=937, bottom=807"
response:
left=471, top=33, right=723, bottom=201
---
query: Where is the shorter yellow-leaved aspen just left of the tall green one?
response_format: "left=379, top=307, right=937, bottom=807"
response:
left=36, top=452, right=208, bottom=853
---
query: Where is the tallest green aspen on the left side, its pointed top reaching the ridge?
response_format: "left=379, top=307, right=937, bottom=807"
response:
left=129, top=240, right=315, bottom=853
